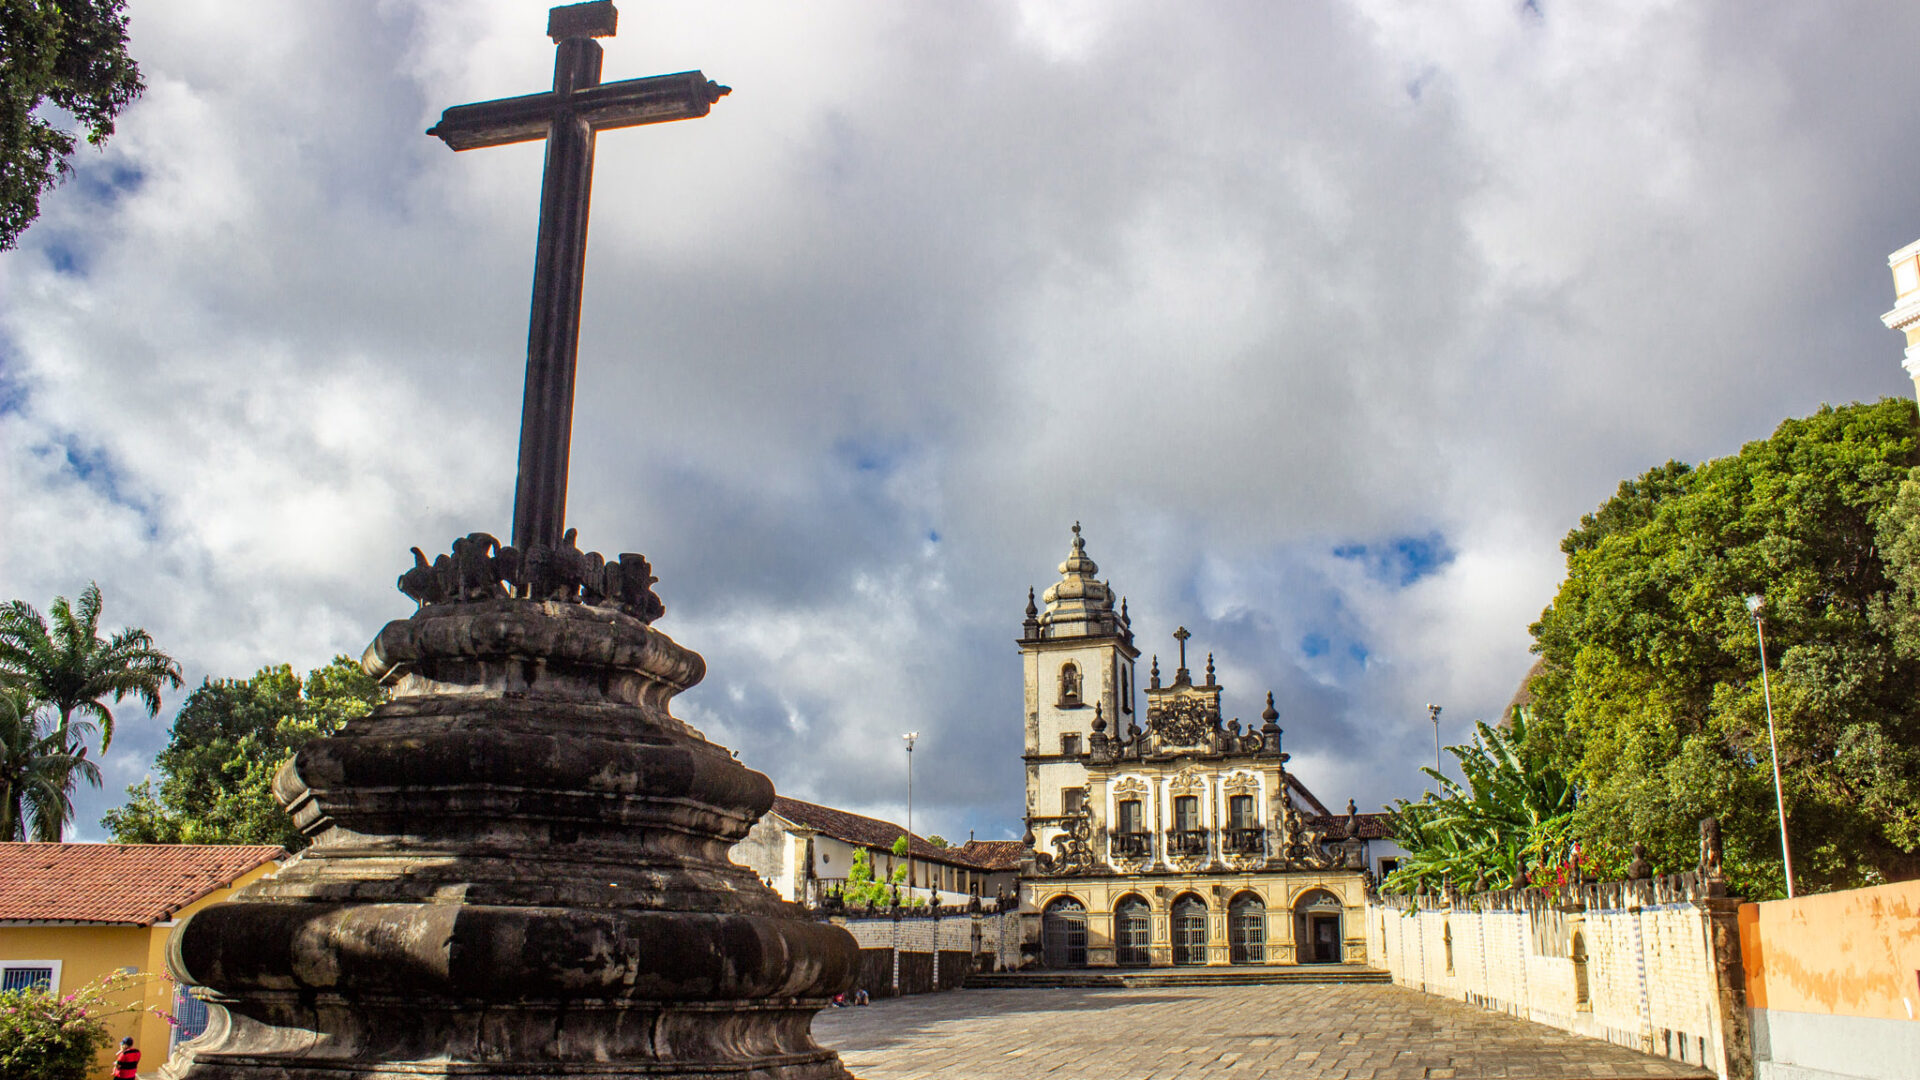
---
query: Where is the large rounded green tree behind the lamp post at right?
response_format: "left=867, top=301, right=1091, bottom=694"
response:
left=1524, top=398, right=1920, bottom=897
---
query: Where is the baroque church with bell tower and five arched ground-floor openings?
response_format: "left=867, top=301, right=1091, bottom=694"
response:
left=1020, top=525, right=1386, bottom=969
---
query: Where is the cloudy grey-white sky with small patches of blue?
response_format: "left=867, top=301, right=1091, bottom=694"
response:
left=0, top=0, right=1920, bottom=840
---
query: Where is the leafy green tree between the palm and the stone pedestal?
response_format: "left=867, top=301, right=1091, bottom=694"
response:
left=100, top=655, right=386, bottom=851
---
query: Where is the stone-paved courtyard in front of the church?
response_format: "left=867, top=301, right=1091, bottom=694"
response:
left=814, top=986, right=1711, bottom=1080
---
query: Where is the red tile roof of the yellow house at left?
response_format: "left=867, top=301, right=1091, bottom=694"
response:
left=0, top=844, right=286, bottom=926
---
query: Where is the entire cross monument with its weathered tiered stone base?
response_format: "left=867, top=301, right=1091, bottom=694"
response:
left=161, top=0, right=858, bottom=1080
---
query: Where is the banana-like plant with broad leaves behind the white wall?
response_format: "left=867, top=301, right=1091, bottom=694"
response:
left=1380, top=707, right=1574, bottom=892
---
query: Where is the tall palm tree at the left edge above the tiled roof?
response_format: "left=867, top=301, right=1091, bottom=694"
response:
left=0, top=580, right=180, bottom=840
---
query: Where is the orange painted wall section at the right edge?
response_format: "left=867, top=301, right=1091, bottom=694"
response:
left=1740, top=882, right=1920, bottom=1022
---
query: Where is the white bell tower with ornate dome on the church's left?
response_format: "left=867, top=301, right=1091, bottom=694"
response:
left=1020, top=521, right=1140, bottom=851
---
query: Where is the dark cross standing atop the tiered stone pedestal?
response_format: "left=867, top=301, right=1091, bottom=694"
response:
left=426, top=0, right=730, bottom=552
